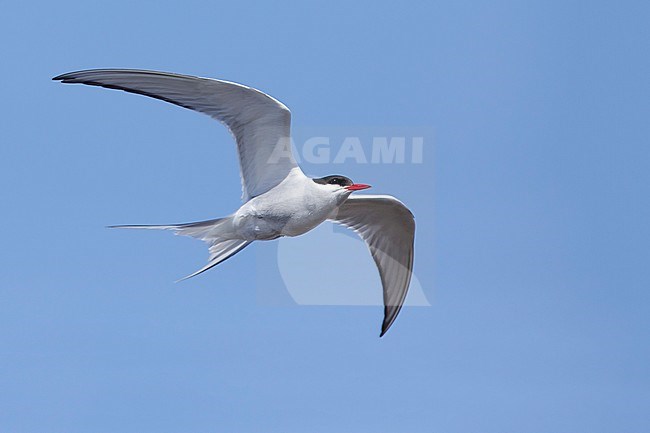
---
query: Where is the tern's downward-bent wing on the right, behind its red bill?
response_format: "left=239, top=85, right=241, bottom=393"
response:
left=330, top=195, right=415, bottom=336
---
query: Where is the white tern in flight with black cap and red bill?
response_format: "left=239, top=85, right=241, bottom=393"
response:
left=53, top=69, right=415, bottom=337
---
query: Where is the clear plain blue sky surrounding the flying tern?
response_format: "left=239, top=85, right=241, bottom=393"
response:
left=0, top=1, right=650, bottom=433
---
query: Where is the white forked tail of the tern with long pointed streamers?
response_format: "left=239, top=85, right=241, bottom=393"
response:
left=108, top=217, right=252, bottom=281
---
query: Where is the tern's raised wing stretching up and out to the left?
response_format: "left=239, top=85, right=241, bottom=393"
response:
left=53, top=69, right=297, bottom=201
